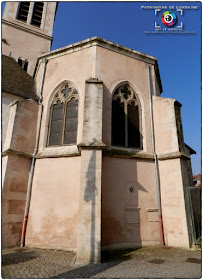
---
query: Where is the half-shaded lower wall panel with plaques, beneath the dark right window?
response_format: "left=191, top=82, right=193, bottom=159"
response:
left=102, top=157, right=159, bottom=249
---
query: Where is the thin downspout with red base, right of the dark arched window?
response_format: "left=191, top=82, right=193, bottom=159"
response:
left=147, top=63, right=165, bottom=246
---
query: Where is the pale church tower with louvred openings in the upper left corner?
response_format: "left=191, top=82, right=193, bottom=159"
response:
left=2, top=2, right=57, bottom=76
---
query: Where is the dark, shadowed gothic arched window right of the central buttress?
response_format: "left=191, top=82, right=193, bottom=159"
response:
left=112, top=84, right=142, bottom=148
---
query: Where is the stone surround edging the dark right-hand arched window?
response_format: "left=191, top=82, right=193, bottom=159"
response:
left=111, top=81, right=145, bottom=151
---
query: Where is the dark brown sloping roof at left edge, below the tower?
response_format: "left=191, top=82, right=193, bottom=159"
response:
left=2, top=55, right=39, bottom=100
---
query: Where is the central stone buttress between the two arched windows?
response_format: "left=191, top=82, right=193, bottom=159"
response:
left=77, top=79, right=103, bottom=263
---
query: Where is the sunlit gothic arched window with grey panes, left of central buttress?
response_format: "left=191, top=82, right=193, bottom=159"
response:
left=47, top=83, right=79, bottom=146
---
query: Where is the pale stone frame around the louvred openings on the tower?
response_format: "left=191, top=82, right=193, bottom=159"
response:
left=15, top=1, right=48, bottom=30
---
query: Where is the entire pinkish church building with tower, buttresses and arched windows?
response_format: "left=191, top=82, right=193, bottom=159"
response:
left=2, top=2, right=195, bottom=263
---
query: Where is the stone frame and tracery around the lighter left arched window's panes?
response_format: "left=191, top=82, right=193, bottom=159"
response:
left=45, top=81, right=79, bottom=148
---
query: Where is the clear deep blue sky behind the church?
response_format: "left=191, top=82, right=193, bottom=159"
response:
left=1, top=1, right=201, bottom=175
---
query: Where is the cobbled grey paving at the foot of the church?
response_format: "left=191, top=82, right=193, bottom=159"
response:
left=1, top=247, right=201, bottom=279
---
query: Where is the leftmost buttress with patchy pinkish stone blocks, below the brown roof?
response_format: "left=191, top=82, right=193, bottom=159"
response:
left=2, top=98, right=38, bottom=247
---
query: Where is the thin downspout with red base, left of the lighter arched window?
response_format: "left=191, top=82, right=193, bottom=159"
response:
left=21, top=58, right=48, bottom=247
